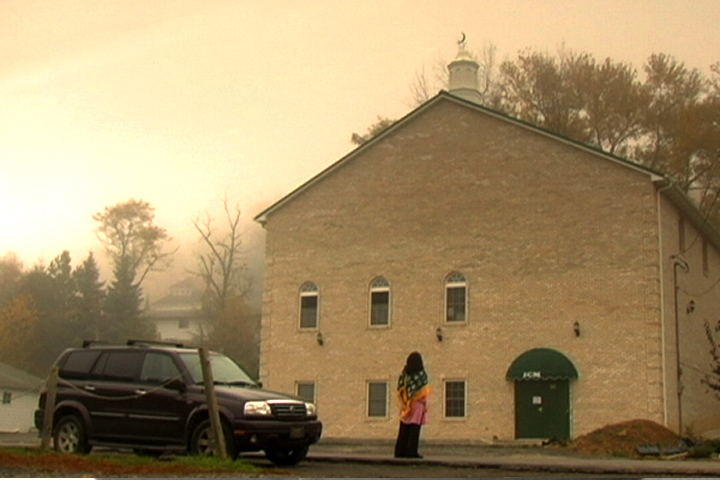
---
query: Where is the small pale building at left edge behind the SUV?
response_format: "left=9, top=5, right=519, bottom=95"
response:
left=0, top=363, right=44, bottom=433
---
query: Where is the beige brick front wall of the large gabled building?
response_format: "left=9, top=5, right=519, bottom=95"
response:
left=261, top=100, right=717, bottom=440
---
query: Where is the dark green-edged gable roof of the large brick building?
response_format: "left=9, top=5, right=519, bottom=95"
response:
left=253, top=90, right=720, bottom=250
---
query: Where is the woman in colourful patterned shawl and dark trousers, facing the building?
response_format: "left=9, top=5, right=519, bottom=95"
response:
left=395, top=352, right=430, bottom=458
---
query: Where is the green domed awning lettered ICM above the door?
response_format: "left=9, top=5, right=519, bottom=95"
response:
left=505, top=348, right=577, bottom=380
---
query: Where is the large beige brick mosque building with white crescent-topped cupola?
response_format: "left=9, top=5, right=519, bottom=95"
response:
left=255, top=43, right=720, bottom=441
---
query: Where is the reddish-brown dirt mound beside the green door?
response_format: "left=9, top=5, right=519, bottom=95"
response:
left=571, top=420, right=682, bottom=458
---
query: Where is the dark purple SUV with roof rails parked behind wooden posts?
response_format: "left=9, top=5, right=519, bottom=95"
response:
left=35, top=341, right=322, bottom=465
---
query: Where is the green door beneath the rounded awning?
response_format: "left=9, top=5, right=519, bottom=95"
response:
left=515, top=380, right=570, bottom=440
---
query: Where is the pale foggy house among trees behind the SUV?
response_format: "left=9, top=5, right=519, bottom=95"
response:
left=146, top=278, right=206, bottom=343
